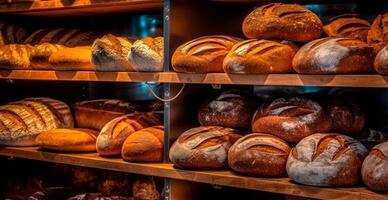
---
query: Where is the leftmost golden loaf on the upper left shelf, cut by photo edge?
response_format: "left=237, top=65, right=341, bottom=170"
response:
left=0, top=44, right=32, bottom=69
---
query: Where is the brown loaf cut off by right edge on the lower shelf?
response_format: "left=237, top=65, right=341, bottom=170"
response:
left=361, top=142, right=388, bottom=192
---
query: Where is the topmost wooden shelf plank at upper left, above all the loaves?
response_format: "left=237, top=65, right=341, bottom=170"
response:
left=0, top=0, right=163, bottom=16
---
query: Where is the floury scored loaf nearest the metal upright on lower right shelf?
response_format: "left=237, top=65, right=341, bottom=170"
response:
left=170, top=126, right=241, bottom=169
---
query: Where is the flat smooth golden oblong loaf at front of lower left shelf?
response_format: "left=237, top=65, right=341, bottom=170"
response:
left=35, top=128, right=98, bottom=152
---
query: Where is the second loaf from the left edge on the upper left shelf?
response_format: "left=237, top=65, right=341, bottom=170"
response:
left=30, top=43, right=64, bottom=70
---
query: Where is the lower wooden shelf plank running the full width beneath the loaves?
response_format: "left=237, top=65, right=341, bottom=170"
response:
left=0, top=147, right=388, bottom=200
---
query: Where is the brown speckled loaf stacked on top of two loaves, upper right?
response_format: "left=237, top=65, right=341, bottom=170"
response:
left=242, top=3, right=322, bottom=42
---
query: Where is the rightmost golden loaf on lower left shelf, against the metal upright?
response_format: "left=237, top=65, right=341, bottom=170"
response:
left=121, top=126, right=164, bottom=162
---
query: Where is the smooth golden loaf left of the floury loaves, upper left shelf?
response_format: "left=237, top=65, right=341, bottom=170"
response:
left=49, top=46, right=96, bottom=71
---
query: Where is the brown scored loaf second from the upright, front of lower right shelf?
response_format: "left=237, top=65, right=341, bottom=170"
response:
left=228, top=133, right=291, bottom=177
